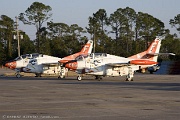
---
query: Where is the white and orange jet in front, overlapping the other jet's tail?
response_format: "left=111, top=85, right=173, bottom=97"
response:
left=65, top=38, right=174, bottom=81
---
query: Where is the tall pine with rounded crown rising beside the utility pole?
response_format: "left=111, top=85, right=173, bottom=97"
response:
left=19, top=2, right=52, bottom=54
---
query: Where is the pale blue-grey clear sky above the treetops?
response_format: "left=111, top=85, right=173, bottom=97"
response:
left=0, top=0, right=180, bottom=39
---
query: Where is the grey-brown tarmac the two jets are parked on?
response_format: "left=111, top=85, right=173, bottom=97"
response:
left=0, top=69, right=180, bottom=120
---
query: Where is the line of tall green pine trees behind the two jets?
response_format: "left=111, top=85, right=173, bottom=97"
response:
left=0, top=2, right=180, bottom=64
